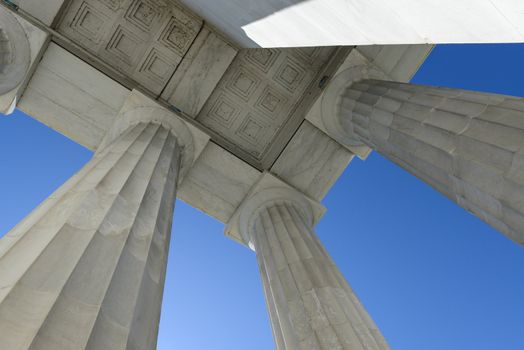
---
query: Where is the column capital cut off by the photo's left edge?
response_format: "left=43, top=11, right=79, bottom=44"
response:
left=0, top=6, right=49, bottom=114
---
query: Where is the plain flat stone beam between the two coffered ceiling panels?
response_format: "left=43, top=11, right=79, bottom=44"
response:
left=162, top=27, right=237, bottom=118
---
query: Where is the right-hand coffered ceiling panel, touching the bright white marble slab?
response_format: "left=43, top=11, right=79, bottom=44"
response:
left=197, top=47, right=334, bottom=159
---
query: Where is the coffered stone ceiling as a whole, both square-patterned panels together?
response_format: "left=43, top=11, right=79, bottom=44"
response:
left=57, top=0, right=343, bottom=169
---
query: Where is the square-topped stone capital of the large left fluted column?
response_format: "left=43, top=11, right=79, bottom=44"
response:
left=97, top=90, right=210, bottom=181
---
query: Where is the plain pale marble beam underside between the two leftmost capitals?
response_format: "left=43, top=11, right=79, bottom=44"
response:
left=19, top=43, right=129, bottom=150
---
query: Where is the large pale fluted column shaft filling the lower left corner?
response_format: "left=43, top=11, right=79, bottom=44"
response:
left=0, top=123, right=181, bottom=350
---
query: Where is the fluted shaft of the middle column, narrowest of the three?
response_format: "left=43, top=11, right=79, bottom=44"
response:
left=250, top=201, right=389, bottom=350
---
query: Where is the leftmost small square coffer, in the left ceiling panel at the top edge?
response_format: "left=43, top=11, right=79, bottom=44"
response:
left=70, top=2, right=108, bottom=43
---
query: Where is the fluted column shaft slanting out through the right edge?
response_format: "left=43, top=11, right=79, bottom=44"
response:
left=338, top=80, right=524, bottom=244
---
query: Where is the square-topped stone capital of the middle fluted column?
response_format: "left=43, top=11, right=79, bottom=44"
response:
left=225, top=172, right=326, bottom=250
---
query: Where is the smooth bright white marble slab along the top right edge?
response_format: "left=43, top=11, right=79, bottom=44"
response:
left=181, top=0, right=524, bottom=47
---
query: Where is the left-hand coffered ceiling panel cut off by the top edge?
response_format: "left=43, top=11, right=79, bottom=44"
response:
left=58, top=0, right=202, bottom=94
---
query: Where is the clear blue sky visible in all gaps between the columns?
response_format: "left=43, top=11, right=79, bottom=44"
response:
left=0, top=45, right=524, bottom=350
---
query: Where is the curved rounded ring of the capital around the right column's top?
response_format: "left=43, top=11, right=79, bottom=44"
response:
left=320, top=65, right=389, bottom=158
